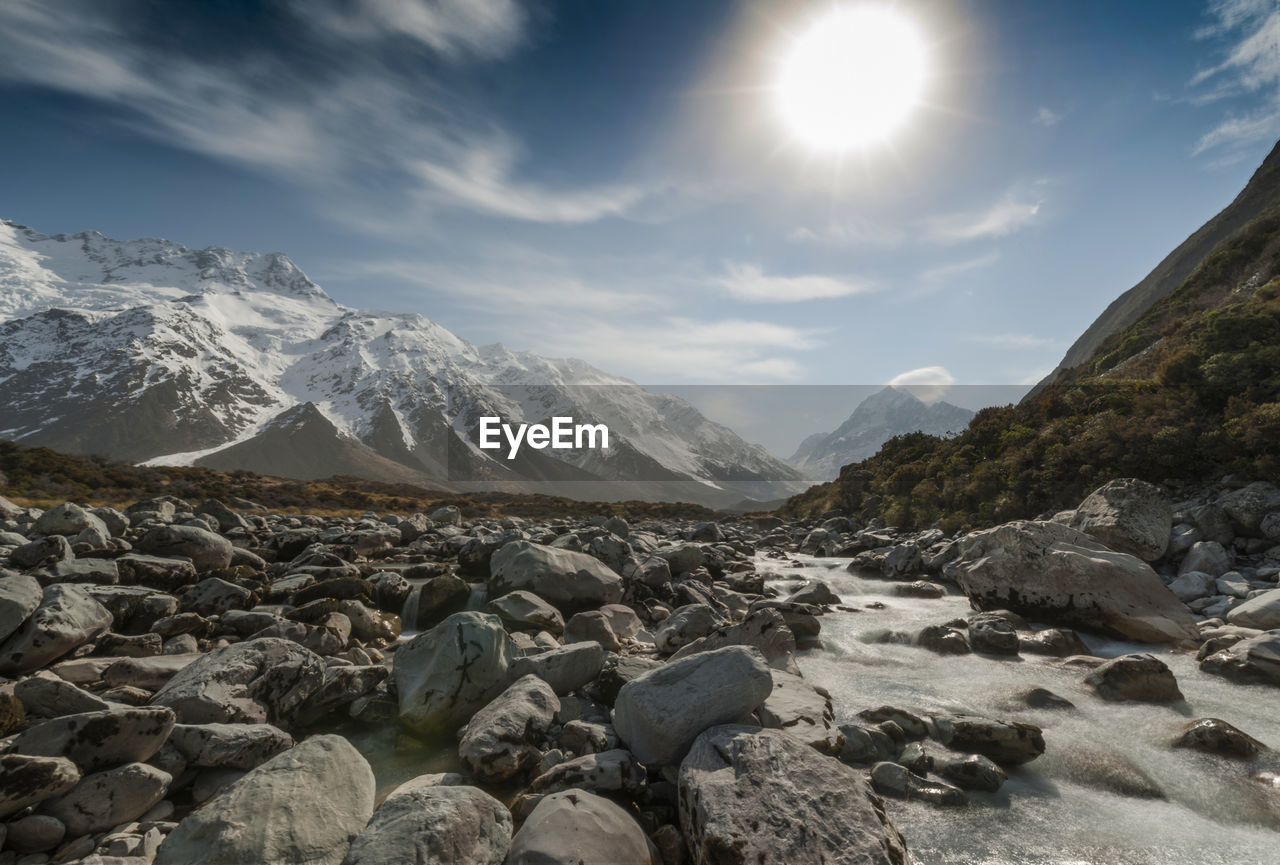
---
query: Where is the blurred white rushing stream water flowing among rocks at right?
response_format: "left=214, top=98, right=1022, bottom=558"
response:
left=758, top=557, right=1280, bottom=865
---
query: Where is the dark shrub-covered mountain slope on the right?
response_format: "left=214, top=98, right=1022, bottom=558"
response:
left=783, top=138, right=1280, bottom=528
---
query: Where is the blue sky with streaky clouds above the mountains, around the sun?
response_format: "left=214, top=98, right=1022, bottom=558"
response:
left=0, top=0, right=1280, bottom=394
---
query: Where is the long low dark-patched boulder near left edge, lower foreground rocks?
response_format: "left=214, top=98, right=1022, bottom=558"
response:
left=13, top=706, right=174, bottom=772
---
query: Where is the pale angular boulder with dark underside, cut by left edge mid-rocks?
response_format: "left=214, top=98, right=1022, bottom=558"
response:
left=0, top=583, right=111, bottom=676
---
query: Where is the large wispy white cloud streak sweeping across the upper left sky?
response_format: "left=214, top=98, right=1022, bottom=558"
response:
left=0, top=0, right=652, bottom=230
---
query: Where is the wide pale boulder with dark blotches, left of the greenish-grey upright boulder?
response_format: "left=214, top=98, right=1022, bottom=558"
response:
left=151, top=637, right=325, bottom=726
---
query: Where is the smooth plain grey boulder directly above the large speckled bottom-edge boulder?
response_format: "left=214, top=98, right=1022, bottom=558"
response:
left=613, top=646, right=773, bottom=764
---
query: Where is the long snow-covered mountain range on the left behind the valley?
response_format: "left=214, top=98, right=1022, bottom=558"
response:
left=0, top=220, right=805, bottom=505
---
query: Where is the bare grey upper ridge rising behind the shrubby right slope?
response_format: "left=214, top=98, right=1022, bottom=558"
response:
left=1033, top=142, right=1280, bottom=393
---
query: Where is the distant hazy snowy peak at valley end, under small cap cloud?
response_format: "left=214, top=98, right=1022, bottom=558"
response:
left=788, top=388, right=973, bottom=480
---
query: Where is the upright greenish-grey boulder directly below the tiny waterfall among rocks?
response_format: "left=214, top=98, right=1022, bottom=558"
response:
left=394, top=609, right=515, bottom=736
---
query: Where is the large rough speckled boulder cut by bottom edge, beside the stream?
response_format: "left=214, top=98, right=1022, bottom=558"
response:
left=680, top=726, right=910, bottom=865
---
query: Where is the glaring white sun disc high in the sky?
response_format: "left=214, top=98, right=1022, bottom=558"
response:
left=773, top=5, right=928, bottom=154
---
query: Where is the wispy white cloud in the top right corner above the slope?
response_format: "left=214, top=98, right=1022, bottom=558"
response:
left=1189, top=0, right=1280, bottom=156
